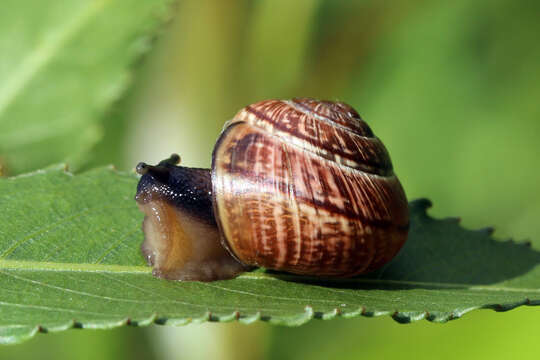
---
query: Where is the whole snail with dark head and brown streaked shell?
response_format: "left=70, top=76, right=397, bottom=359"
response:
left=135, top=98, right=409, bottom=281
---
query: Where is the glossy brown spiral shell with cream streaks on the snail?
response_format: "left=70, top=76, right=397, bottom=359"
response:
left=212, top=98, right=409, bottom=277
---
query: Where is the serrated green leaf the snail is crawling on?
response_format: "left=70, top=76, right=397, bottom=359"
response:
left=0, top=167, right=540, bottom=343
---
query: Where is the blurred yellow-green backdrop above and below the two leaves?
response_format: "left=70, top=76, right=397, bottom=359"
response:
left=0, top=0, right=540, bottom=359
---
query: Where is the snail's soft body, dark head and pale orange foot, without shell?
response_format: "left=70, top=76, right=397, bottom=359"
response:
left=135, top=154, right=246, bottom=281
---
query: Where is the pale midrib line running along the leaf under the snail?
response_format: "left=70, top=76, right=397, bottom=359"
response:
left=0, top=260, right=540, bottom=293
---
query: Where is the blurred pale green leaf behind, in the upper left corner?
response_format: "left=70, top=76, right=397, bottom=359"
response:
left=0, top=0, right=170, bottom=174
